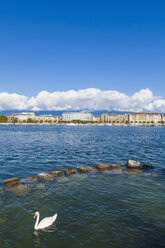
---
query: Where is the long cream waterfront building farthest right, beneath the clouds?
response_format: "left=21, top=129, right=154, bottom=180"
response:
left=128, top=113, right=161, bottom=123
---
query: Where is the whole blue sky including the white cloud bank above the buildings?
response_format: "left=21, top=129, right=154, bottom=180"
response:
left=0, top=0, right=165, bottom=112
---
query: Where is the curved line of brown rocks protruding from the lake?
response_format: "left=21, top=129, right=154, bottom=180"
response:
left=4, top=160, right=154, bottom=194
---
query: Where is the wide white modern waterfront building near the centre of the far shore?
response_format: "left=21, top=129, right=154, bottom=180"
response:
left=62, top=112, right=94, bottom=121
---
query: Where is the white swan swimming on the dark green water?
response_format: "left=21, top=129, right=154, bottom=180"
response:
left=33, top=211, right=57, bottom=230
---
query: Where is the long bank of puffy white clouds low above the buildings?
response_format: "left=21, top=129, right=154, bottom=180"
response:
left=0, top=88, right=165, bottom=112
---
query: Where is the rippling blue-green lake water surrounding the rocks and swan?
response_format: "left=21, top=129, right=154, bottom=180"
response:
left=0, top=126, right=165, bottom=248
